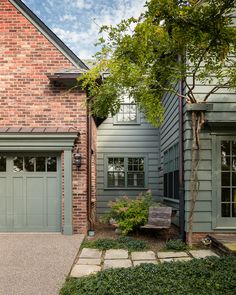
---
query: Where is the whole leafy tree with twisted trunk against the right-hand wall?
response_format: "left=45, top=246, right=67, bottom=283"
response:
left=80, top=0, right=236, bottom=245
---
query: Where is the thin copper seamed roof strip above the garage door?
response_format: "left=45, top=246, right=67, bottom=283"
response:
left=0, top=127, right=79, bottom=133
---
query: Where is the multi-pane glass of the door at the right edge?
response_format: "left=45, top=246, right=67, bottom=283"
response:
left=221, top=140, right=236, bottom=217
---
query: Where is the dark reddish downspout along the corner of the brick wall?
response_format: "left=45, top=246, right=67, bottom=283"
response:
left=87, top=106, right=94, bottom=232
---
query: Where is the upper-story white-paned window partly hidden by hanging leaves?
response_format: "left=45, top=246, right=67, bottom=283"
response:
left=114, top=95, right=140, bottom=124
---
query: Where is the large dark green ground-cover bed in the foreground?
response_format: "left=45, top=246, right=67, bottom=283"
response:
left=60, top=257, right=236, bottom=295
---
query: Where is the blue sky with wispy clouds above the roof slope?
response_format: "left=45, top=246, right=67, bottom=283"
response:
left=23, top=0, right=145, bottom=59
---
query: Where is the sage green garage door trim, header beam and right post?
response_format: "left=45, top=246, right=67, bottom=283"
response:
left=0, top=131, right=78, bottom=235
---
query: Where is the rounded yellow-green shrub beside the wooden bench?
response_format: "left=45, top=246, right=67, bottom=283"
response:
left=101, top=191, right=156, bottom=235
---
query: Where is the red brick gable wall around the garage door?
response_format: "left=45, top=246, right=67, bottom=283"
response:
left=0, top=0, right=87, bottom=233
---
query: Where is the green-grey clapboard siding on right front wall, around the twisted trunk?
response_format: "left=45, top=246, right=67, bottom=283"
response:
left=184, top=57, right=236, bottom=232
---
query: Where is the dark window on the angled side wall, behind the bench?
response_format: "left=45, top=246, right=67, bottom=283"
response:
left=164, top=144, right=179, bottom=199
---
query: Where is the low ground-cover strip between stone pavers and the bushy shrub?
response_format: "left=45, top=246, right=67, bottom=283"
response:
left=81, top=236, right=148, bottom=251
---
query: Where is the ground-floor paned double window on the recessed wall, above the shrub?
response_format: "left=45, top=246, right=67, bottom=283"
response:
left=107, top=157, right=145, bottom=188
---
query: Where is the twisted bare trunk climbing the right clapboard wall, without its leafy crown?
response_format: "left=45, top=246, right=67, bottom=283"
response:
left=187, top=111, right=204, bottom=247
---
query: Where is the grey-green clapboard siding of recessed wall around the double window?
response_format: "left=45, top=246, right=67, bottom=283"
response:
left=97, top=114, right=160, bottom=216
